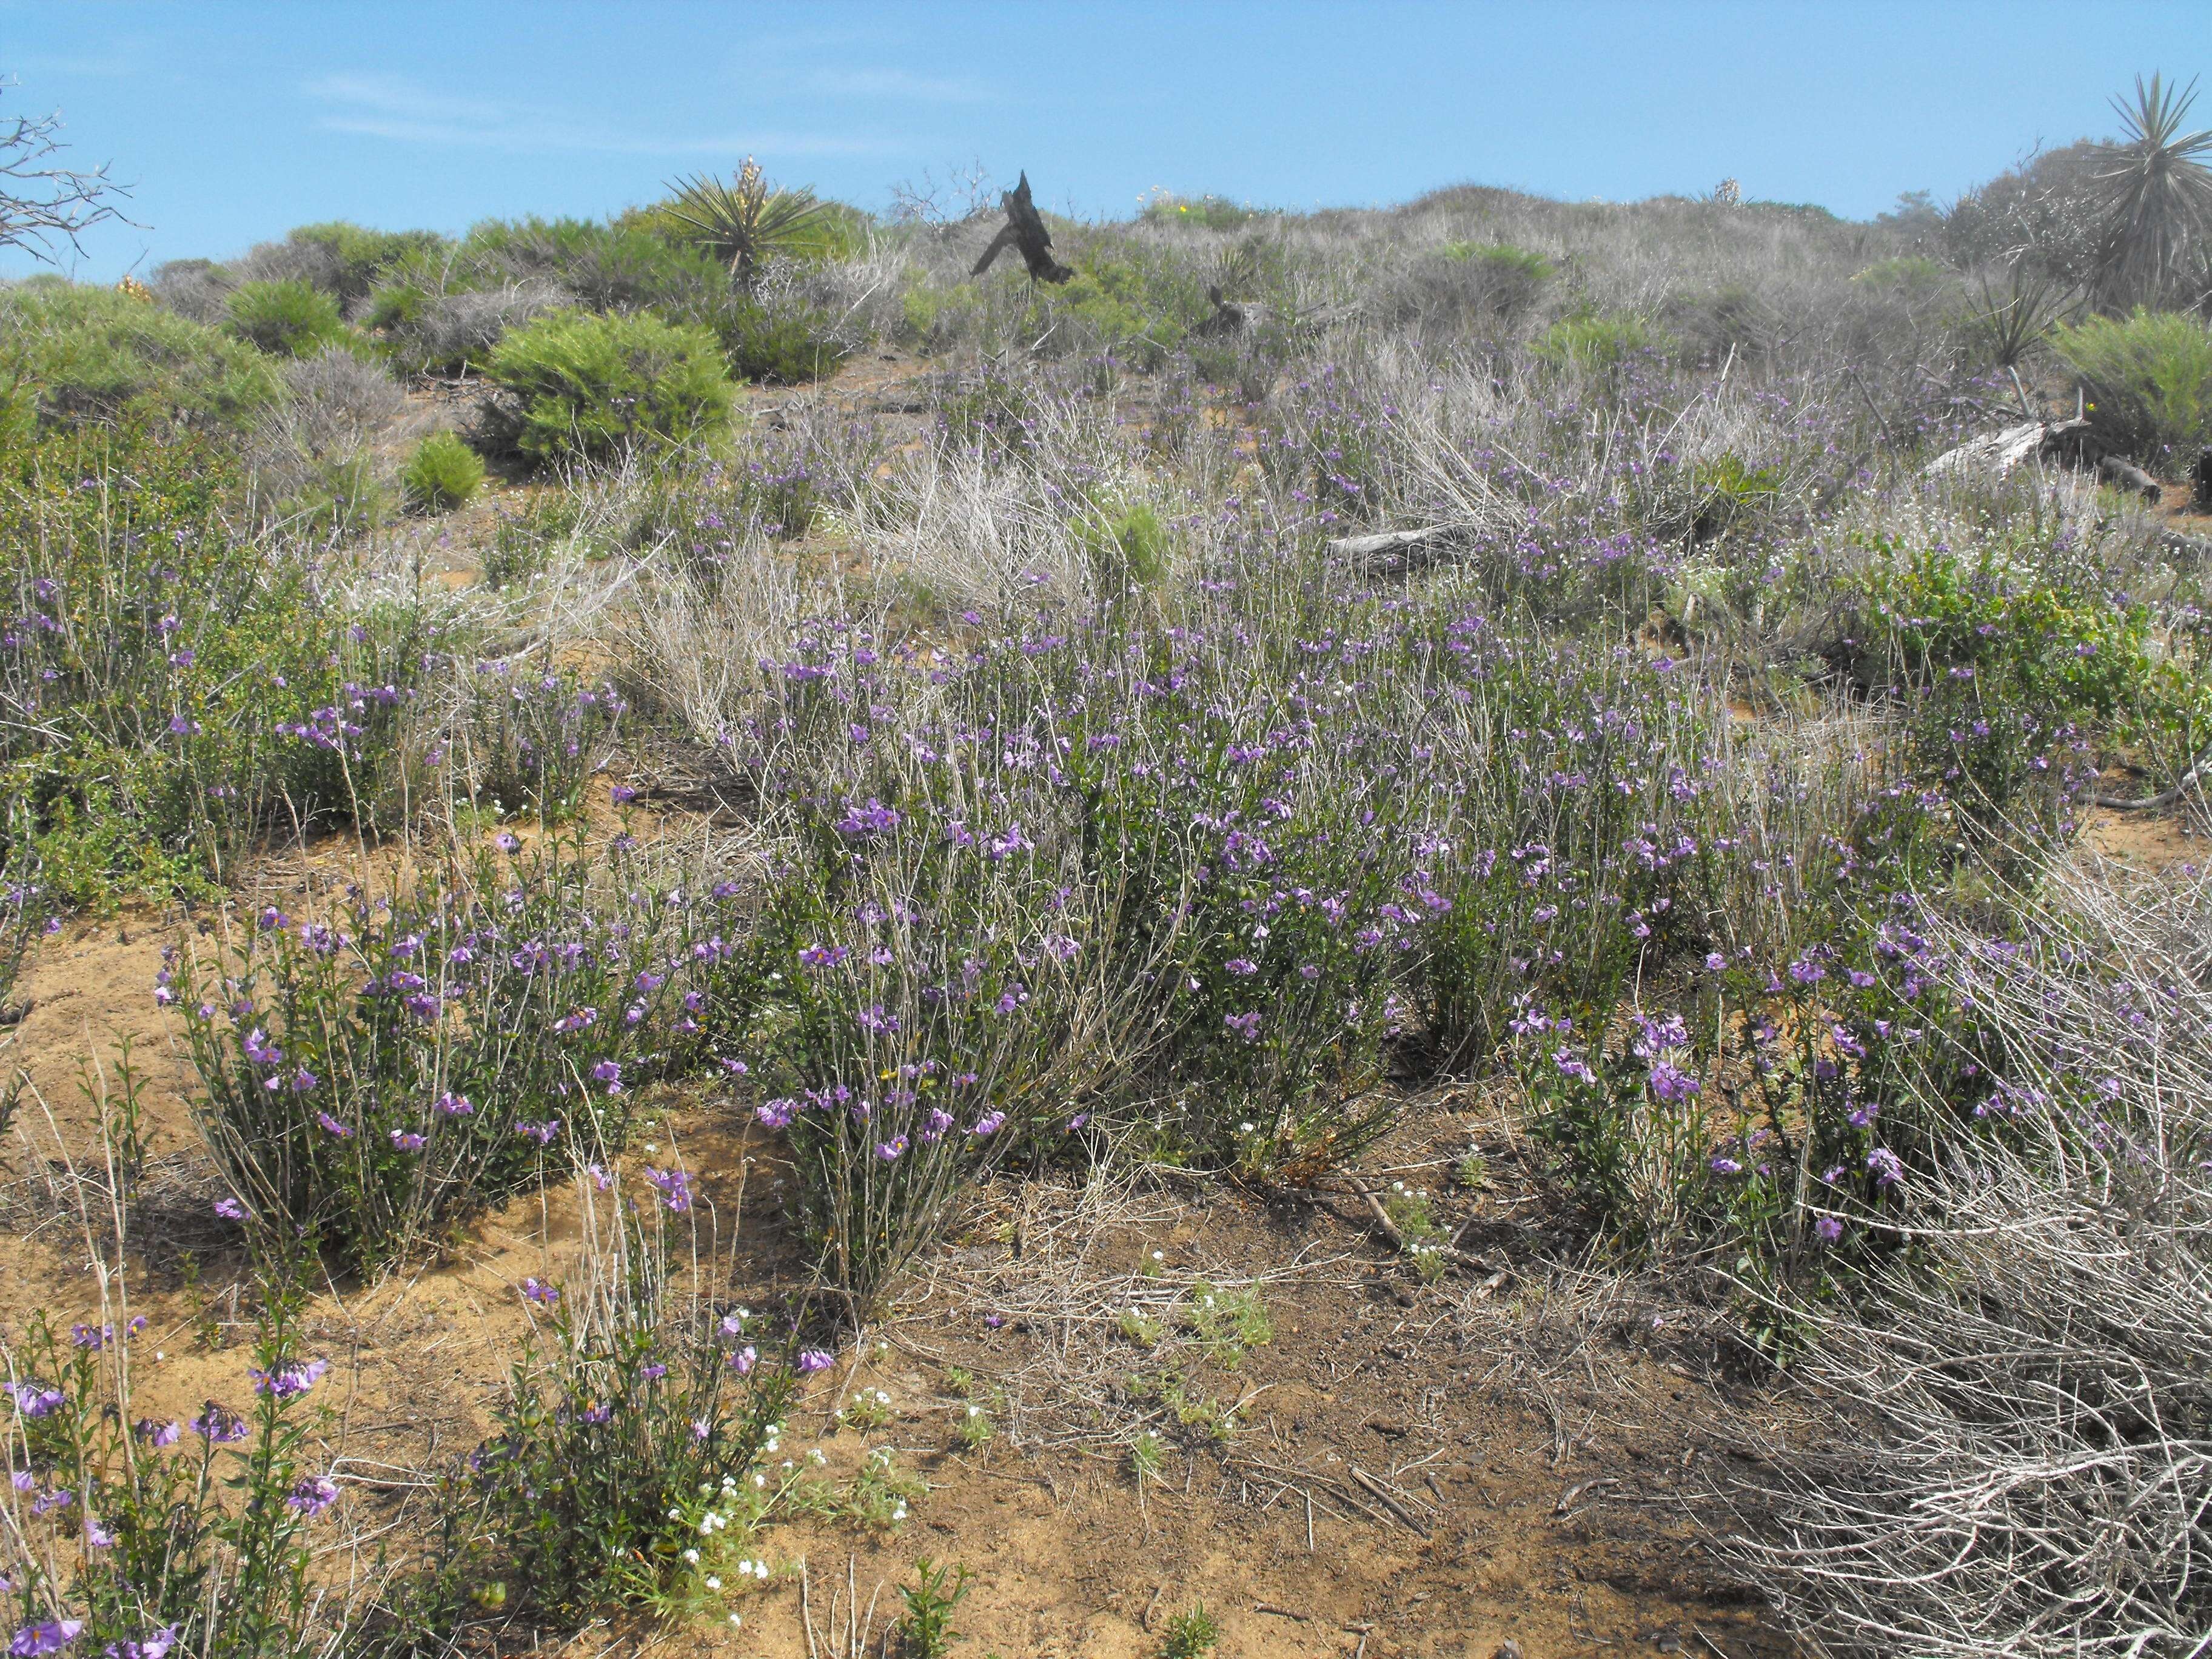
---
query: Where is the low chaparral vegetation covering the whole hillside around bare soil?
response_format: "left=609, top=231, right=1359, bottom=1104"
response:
left=0, top=82, right=2212, bottom=1659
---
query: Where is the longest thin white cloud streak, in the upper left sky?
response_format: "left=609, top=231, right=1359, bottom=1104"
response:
left=303, top=75, right=889, bottom=157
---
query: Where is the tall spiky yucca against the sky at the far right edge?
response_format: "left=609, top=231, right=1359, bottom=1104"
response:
left=2097, top=75, right=2212, bottom=307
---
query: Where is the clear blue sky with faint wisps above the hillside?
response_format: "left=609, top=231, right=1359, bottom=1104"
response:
left=0, top=0, right=2212, bottom=281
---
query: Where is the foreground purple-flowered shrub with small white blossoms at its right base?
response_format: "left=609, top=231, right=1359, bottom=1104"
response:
left=387, top=1179, right=812, bottom=1641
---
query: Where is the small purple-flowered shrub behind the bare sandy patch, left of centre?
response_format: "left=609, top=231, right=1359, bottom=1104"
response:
left=449, top=659, right=626, bottom=823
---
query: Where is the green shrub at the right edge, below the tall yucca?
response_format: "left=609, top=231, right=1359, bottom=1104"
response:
left=2055, top=310, right=2212, bottom=471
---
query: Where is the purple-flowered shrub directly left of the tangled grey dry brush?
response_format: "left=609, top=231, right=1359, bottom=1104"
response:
left=1513, top=865, right=2020, bottom=1283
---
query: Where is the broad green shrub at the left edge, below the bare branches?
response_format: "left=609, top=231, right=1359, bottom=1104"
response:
left=0, top=283, right=281, bottom=440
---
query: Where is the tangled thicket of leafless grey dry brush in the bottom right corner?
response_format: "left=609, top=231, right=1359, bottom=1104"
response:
left=1737, top=880, right=2212, bottom=1657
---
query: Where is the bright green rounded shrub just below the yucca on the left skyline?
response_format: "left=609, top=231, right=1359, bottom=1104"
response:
left=491, top=312, right=734, bottom=462
